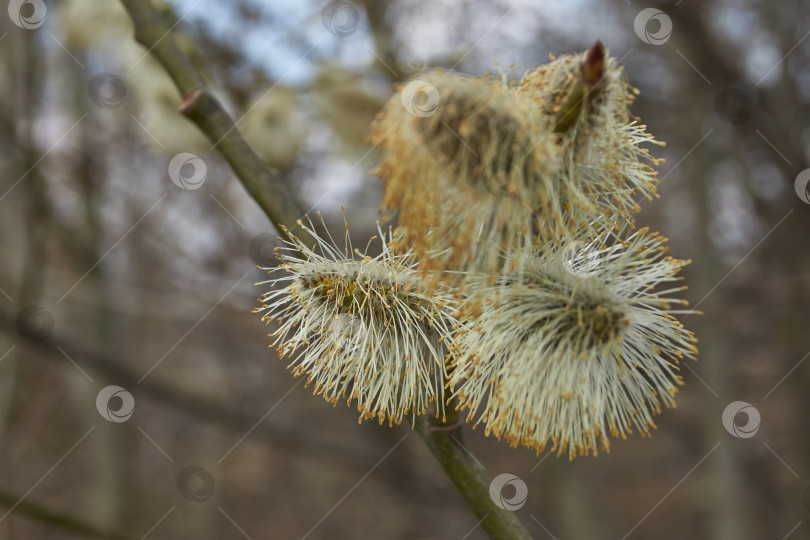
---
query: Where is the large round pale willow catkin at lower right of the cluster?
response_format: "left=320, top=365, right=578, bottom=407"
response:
left=451, top=229, right=697, bottom=457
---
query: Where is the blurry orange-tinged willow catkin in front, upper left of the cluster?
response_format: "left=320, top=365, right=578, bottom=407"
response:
left=372, top=72, right=562, bottom=272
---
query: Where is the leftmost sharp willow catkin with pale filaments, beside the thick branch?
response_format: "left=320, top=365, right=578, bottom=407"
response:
left=255, top=215, right=455, bottom=424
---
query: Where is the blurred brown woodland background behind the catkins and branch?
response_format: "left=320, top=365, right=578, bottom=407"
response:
left=0, top=0, right=810, bottom=540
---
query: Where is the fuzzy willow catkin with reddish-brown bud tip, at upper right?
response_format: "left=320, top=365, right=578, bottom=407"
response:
left=518, top=45, right=663, bottom=224
